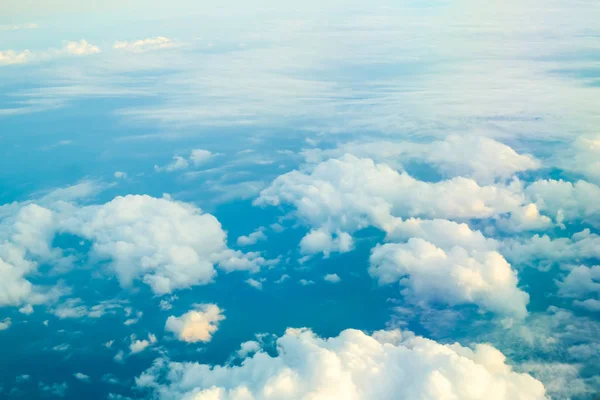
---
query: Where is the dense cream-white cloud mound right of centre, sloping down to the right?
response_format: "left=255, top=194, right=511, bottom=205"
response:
left=369, top=238, right=529, bottom=318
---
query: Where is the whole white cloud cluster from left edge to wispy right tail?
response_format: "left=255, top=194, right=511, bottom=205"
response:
left=0, top=183, right=270, bottom=306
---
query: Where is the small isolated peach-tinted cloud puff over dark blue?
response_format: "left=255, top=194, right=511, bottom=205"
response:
left=165, top=304, right=225, bottom=343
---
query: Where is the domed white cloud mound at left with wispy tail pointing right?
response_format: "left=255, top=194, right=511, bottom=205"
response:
left=61, top=195, right=268, bottom=294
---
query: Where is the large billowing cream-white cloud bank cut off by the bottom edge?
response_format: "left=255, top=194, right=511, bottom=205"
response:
left=136, top=329, right=546, bottom=400
